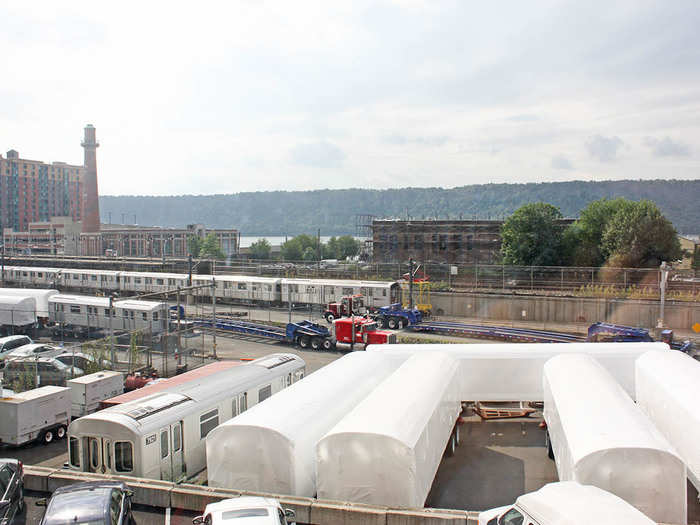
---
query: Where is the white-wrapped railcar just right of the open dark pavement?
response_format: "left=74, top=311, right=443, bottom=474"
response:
left=543, top=355, right=687, bottom=524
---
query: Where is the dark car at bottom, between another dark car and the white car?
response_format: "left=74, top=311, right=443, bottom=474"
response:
left=36, top=481, right=136, bottom=525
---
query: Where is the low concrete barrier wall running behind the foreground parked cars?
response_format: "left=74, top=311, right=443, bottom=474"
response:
left=24, top=465, right=478, bottom=525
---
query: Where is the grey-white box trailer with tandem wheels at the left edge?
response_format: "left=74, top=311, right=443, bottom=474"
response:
left=0, top=386, right=70, bottom=445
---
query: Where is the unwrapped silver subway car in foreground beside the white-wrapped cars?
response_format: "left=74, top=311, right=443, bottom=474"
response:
left=68, top=354, right=306, bottom=480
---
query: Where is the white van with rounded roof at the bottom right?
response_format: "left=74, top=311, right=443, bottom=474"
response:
left=479, top=481, right=654, bottom=525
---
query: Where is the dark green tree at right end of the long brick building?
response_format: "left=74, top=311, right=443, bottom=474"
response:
left=501, top=202, right=564, bottom=266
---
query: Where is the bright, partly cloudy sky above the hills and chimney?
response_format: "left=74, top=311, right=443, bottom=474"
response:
left=0, top=0, right=700, bottom=195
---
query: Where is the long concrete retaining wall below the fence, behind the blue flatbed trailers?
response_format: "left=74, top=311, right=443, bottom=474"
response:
left=431, top=292, right=700, bottom=330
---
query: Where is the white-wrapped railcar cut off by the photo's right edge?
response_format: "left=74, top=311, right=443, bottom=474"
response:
left=636, top=352, right=700, bottom=490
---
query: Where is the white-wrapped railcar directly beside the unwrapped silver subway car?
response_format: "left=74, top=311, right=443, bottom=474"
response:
left=206, top=352, right=398, bottom=497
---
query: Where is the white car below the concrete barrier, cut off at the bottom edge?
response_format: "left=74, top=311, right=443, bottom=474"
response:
left=192, top=496, right=296, bottom=525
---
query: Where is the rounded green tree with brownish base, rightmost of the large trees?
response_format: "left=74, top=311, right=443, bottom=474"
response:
left=601, top=200, right=683, bottom=268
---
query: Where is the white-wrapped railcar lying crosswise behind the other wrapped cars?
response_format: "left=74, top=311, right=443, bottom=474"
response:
left=367, top=343, right=668, bottom=401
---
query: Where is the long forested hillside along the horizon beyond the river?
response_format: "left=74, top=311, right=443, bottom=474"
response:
left=100, top=179, right=700, bottom=235
